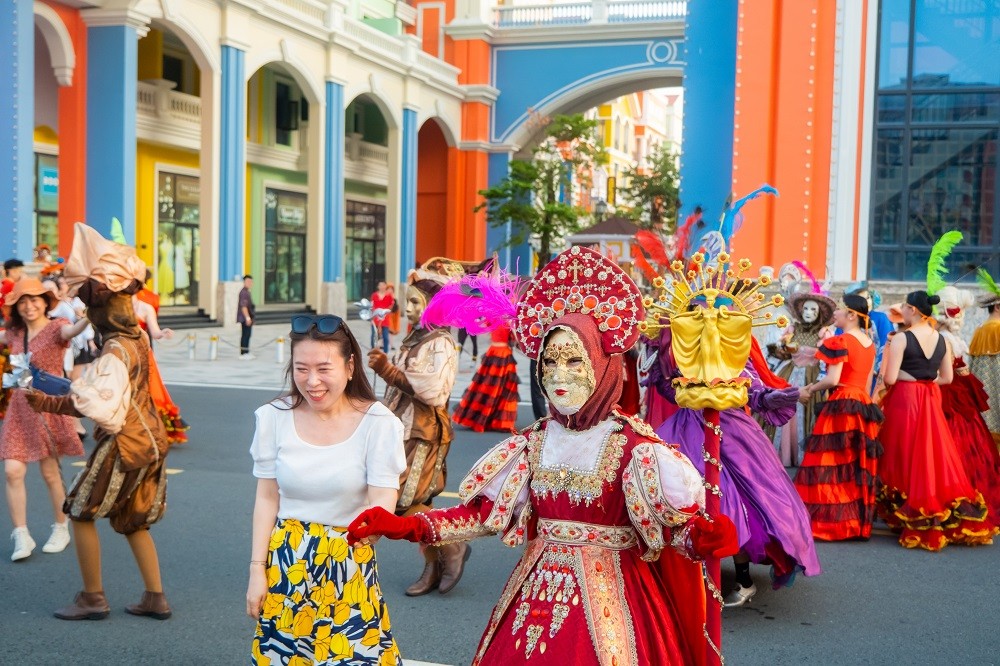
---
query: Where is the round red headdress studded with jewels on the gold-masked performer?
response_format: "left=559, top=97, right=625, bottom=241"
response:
left=514, top=247, right=646, bottom=358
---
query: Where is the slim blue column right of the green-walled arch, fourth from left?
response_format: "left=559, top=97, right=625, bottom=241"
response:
left=323, top=81, right=345, bottom=282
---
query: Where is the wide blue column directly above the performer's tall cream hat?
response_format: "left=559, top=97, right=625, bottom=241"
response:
left=87, top=24, right=139, bottom=244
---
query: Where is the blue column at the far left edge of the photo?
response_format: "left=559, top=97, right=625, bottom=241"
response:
left=0, top=2, right=35, bottom=261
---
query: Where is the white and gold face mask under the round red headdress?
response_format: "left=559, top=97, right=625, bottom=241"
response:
left=539, top=328, right=597, bottom=416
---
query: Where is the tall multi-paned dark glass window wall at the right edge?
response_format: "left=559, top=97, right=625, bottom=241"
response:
left=869, top=0, right=1000, bottom=281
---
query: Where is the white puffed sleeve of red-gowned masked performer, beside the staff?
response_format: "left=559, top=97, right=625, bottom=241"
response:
left=622, top=441, right=705, bottom=560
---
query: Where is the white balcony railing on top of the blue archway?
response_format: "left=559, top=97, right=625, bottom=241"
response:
left=493, top=0, right=687, bottom=28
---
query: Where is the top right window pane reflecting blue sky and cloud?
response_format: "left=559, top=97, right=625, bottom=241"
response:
left=916, top=0, right=1000, bottom=88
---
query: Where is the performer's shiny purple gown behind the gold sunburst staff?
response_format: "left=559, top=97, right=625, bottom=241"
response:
left=649, top=329, right=821, bottom=589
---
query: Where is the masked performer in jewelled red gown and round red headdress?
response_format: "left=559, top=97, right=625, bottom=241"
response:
left=349, top=247, right=736, bottom=666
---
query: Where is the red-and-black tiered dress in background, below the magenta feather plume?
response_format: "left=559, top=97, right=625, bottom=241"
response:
left=451, top=326, right=520, bottom=432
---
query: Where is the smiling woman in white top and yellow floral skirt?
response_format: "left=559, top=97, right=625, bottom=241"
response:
left=247, top=315, right=406, bottom=666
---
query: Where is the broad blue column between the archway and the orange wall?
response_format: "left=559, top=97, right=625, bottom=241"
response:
left=679, top=0, right=738, bottom=220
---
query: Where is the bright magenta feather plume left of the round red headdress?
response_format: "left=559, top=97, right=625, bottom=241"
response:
left=420, top=270, right=519, bottom=335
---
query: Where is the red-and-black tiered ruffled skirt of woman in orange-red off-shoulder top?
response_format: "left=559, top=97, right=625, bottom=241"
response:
left=795, top=386, right=883, bottom=541
